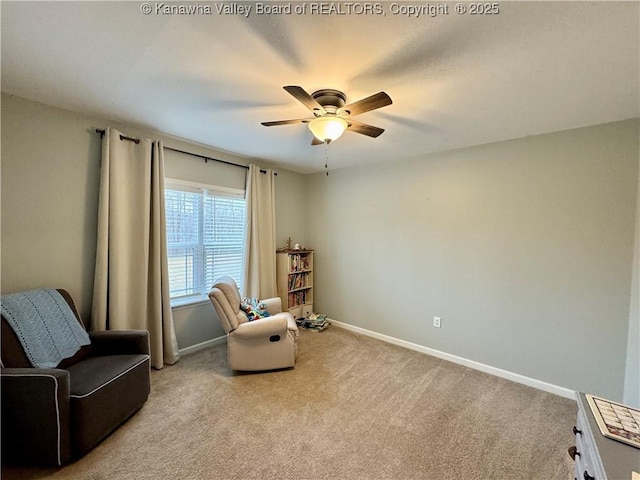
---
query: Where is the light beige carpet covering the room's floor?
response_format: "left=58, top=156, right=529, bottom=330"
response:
left=2, top=326, right=577, bottom=480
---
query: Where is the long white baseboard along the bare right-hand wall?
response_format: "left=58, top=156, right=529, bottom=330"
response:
left=330, top=319, right=576, bottom=400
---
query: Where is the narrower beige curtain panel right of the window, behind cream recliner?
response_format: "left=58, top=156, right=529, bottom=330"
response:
left=244, top=165, right=277, bottom=298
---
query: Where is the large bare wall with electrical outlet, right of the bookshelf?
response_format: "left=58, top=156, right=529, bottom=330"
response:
left=306, top=120, right=639, bottom=400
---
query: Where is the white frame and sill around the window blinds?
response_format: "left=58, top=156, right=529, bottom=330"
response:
left=164, top=178, right=247, bottom=309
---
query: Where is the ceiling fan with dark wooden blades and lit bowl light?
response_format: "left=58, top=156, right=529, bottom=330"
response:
left=262, top=85, right=392, bottom=145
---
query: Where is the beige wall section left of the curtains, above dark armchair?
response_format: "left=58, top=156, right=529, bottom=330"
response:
left=0, top=94, right=102, bottom=318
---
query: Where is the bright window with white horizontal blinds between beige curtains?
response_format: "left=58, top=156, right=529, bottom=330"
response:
left=165, top=180, right=245, bottom=303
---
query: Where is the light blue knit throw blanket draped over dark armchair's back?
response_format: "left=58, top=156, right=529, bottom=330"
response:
left=0, top=289, right=91, bottom=368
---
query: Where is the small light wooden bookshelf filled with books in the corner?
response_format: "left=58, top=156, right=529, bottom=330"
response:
left=276, top=250, right=313, bottom=320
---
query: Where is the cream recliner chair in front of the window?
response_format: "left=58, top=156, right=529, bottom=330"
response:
left=209, top=276, right=298, bottom=371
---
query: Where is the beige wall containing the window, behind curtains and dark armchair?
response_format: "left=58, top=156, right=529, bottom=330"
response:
left=0, top=94, right=304, bottom=348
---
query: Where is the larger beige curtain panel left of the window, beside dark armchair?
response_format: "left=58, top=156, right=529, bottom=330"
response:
left=91, top=128, right=180, bottom=368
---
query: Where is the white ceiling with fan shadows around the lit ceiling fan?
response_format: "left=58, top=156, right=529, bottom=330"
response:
left=1, top=1, right=640, bottom=172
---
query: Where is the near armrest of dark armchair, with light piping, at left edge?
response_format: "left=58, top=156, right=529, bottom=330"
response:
left=0, top=368, right=71, bottom=465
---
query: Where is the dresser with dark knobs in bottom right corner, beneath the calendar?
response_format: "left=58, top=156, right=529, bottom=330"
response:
left=569, top=393, right=640, bottom=480
